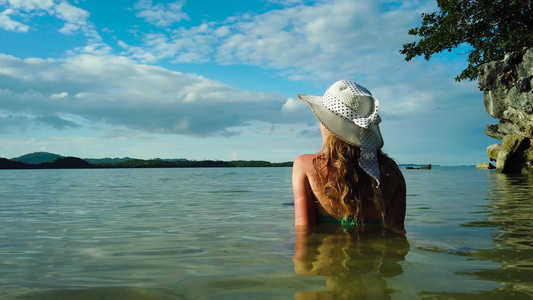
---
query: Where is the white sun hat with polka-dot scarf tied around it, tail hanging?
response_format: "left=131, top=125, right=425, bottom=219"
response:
left=298, top=79, right=383, bottom=185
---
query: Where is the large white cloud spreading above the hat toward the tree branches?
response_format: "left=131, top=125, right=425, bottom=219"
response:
left=114, top=0, right=472, bottom=129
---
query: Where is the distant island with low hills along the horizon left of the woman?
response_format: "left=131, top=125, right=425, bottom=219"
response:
left=0, top=152, right=292, bottom=170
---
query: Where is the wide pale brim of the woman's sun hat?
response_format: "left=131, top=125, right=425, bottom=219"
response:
left=298, top=94, right=383, bottom=149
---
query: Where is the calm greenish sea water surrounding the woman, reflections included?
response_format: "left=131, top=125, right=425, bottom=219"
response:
left=0, top=167, right=533, bottom=299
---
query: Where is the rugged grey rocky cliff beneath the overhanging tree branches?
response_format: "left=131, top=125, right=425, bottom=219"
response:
left=478, top=48, right=533, bottom=173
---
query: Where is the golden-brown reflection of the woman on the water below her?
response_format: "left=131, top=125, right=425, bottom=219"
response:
left=293, top=228, right=409, bottom=299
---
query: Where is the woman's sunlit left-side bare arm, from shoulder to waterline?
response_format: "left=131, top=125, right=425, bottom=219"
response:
left=292, top=155, right=316, bottom=226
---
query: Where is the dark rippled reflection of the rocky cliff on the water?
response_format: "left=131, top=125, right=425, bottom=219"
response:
left=454, top=172, right=533, bottom=299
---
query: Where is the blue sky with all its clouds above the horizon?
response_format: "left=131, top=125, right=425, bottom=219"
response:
left=0, top=0, right=499, bottom=165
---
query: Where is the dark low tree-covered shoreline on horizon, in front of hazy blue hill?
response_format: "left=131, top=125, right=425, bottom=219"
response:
left=0, top=156, right=292, bottom=169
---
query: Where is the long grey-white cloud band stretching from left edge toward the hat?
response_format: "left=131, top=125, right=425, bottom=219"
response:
left=0, top=55, right=292, bottom=136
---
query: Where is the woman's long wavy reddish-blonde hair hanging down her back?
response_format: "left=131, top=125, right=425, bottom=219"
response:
left=313, top=134, right=386, bottom=226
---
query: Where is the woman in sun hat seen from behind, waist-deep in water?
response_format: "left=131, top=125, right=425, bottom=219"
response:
left=292, top=80, right=406, bottom=233
